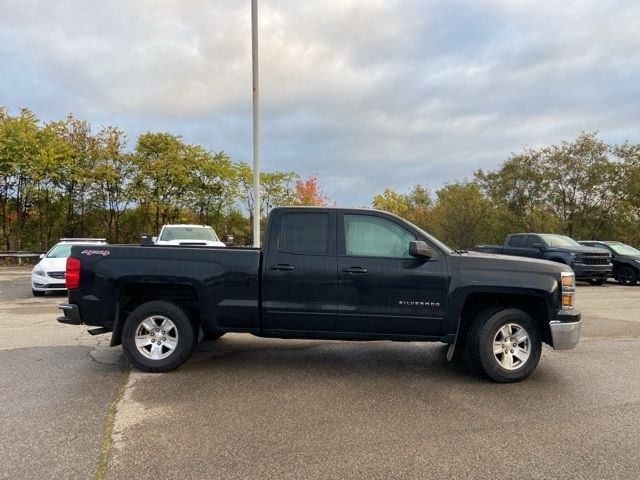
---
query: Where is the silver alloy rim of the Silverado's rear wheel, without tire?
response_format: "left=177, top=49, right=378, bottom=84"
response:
left=135, top=315, right=178, bottom=360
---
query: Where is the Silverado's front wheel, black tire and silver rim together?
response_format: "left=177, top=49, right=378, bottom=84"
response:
left=467, top=308, right=542, bottom=383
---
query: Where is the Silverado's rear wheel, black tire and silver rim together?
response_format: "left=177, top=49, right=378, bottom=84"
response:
left=122, top=300, right=197, bottom=373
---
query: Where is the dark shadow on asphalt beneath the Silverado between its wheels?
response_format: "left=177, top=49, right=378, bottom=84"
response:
left=188, top=334, right=484, bottom=382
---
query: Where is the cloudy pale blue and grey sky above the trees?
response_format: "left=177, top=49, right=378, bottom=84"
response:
left=0, top=0, right=640, bottom=206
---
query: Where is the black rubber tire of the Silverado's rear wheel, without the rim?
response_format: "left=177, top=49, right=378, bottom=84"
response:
left=122, top=300, right=198, bottom=373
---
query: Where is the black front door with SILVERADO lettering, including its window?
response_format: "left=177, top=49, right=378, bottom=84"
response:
left=336, top=212, right=447, bottom=336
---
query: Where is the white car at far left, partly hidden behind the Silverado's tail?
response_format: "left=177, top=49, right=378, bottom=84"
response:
left=31, top=238, right=107, bottom=297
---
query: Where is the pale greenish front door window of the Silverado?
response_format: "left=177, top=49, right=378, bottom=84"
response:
left=344, top=215, right=416, bottom=257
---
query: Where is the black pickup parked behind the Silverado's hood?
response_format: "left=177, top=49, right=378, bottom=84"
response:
left=475, top=233, right=613, bottom=285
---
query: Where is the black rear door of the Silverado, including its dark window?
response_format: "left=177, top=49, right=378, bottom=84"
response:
left=262, top=209, right=338, bottom=331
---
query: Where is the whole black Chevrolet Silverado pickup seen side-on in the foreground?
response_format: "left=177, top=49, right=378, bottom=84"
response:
left=58, top=207, right=581, bottom=382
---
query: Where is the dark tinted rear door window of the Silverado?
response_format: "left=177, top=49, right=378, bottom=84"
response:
left=280, top=212, right=329, bottom=255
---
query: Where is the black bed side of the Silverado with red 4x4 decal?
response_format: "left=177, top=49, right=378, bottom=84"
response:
left=69, top=245, right=262, bottom=331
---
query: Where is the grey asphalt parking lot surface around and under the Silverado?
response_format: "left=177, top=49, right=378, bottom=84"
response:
left=0, top=267, right=640, bottom=479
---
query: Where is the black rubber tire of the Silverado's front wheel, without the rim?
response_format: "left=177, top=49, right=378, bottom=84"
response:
left=467, top=308, right=542, bottom=383
